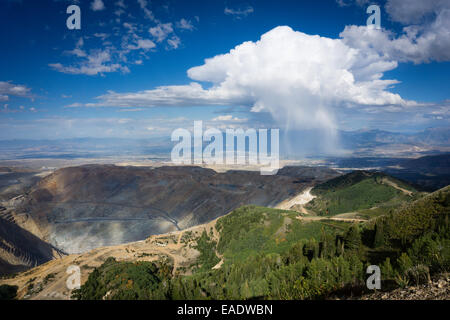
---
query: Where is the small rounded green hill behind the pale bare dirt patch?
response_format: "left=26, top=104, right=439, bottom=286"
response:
left=306, top=171, right=420, bottom=215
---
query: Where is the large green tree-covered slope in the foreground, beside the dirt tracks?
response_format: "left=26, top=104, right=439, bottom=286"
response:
left=74, top=187, right=450, bottom=299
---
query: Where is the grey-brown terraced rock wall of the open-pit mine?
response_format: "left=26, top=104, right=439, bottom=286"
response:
left=15, top=165, right=337, bottom=253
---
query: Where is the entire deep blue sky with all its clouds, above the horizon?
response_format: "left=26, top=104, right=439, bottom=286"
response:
left=0, top=0, right=450, bottom=139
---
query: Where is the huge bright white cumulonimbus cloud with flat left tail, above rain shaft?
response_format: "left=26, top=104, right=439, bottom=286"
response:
left=85, top=26, right=408, bottom=132
